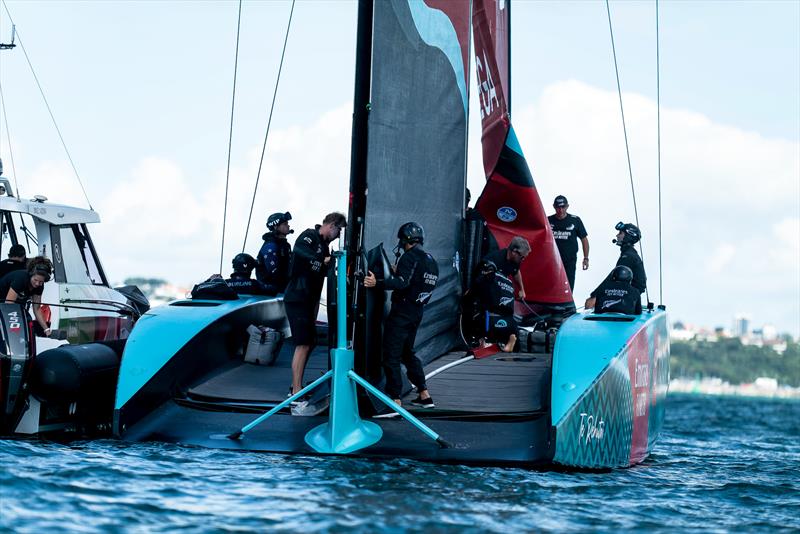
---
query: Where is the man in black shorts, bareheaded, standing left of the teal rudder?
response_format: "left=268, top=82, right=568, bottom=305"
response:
left=283, top=212, right=347, bottom=406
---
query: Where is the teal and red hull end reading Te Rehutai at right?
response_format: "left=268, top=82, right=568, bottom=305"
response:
left=551, top=310, right=669, bottom=469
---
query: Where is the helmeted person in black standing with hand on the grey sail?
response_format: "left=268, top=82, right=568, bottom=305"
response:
left=364, top=222, right=439, bottom=416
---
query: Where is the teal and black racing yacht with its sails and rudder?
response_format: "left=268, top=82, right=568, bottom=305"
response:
left=106, top=0, right=669, bottom=468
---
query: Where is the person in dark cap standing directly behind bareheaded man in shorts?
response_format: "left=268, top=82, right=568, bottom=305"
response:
left=256, top=211, right=294, bottom=294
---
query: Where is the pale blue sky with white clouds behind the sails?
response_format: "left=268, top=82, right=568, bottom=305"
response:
left=0, top=0, right=800, bottom=336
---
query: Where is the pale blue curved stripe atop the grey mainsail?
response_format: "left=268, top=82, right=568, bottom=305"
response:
left=408, top=0, right=467, bottom=115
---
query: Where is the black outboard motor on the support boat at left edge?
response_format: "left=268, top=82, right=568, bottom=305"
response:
left=0, top=303, right=36, bottom=434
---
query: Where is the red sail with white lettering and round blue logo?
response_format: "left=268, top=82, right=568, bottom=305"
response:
left=472, top=0, right=572, bottom=304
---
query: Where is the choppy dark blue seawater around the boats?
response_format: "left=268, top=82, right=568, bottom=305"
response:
left=0, top=396, right=800, bottom=533
